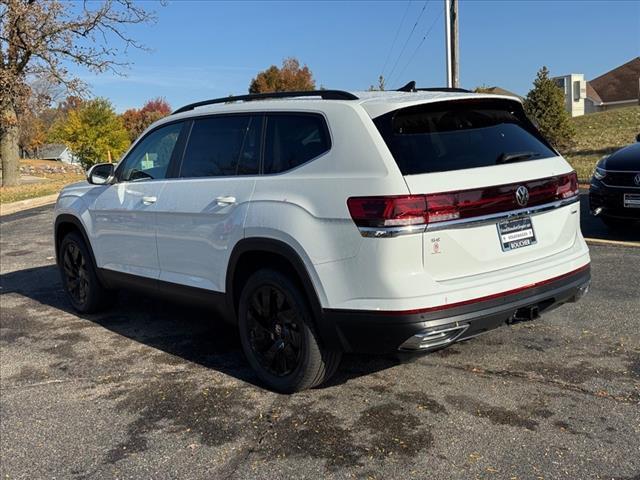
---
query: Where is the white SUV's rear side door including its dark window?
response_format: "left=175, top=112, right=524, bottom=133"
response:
left=157, top=114, right=263, bottom=292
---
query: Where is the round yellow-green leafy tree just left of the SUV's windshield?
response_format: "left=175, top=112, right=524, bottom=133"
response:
left=52, top=98, right=130, bottom=168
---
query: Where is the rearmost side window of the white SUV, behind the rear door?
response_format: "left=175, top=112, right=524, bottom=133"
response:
left=264, top=114, right=331, bottom=173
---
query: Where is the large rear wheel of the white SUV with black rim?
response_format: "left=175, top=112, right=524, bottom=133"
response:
left=238, top=269, right=342, bottom=393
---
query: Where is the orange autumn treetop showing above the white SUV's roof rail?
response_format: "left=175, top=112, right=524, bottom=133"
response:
left=249, top=57, right=316, bottom=93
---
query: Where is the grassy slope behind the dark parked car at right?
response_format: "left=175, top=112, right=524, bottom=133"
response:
left=562, top=106, right=640, bottom=182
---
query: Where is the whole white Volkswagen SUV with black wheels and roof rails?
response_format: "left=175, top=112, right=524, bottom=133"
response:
left=55, top=85, right=590, bottom=392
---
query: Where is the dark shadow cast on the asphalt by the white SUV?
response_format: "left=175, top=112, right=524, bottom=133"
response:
left=0, top=265, right=400, bottom=388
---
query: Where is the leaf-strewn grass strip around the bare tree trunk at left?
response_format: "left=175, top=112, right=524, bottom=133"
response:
left=0, top=160, right=85, bottom=204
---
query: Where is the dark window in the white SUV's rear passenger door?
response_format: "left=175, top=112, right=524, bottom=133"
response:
left=180, top=115, right=262, bottom=178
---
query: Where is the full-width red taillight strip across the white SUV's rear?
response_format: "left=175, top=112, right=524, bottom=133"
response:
left=347, top=172, right=579, bottom=231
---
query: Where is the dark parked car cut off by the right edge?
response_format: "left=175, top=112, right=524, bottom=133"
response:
left=589, top=134, right=640, bottom=228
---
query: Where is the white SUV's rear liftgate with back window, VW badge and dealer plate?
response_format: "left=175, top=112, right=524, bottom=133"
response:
left=374, top=98, right=579, bottom=281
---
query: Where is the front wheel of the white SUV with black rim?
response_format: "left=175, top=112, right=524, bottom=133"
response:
left=59, top=232, right=115, bottom=313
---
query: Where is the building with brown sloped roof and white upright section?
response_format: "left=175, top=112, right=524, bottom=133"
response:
left=554, top=57, right=640, bottom=117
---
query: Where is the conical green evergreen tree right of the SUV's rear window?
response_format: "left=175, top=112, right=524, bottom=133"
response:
left=524, top=67, right=575, bottom=148
